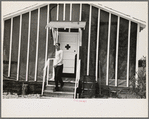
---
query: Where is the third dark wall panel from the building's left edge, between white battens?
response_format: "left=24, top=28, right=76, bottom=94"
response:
left=19, top=13, right=29, bottom=80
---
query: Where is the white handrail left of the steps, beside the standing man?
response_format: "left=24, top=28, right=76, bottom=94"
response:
left=41, top=58, right=54, bottom=95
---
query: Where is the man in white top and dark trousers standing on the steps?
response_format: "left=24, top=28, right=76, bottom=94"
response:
left=53, top=43, right=64, bottom=91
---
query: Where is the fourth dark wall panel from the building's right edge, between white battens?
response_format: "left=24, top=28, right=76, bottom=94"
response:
left=98, top=10, right=109, bottom=85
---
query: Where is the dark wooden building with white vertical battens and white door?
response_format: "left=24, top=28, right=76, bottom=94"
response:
left=3, top=3, right=145, bottom=97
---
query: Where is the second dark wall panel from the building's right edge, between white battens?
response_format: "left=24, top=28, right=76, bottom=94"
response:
left=118, top=18, right=128, bottom=80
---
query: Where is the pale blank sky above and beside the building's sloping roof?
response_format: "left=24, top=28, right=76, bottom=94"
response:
left=2, top=1, right=148, bottom=59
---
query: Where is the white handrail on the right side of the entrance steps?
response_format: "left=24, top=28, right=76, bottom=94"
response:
left=74, top=59, right=81, bottom=99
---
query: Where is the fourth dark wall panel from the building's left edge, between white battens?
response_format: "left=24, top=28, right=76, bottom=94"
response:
left=29, top=10, right=38, bottom=81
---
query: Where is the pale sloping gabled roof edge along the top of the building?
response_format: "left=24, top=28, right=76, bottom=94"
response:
left=3, top=3, right=146, bottom=29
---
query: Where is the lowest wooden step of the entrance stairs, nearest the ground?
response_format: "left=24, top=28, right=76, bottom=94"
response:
left=43, top=90, right=74, bottom=98
